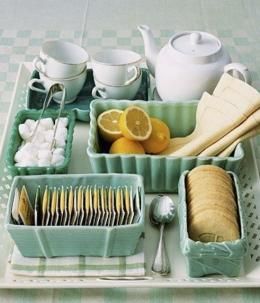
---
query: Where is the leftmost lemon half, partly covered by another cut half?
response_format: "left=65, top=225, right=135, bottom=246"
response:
left=97, top=109, right=123, bottom=142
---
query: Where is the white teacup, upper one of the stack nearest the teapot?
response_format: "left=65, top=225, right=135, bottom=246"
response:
left=91, top=49, right=142, bottom=85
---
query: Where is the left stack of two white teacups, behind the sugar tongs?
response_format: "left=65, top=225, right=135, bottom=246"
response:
left=28, top=40, right=89, bottom=103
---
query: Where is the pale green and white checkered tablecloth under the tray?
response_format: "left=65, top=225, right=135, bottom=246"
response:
left=0, top=0, right=260, bottom=303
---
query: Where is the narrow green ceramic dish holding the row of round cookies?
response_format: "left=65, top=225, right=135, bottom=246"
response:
left=178, top=171, right=247, bottom=277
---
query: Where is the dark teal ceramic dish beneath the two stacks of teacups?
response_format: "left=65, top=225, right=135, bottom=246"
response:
left=27, top=68, right=150, bottom=122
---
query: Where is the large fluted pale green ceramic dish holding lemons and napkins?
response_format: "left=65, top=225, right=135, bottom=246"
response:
left=87, top=100, right=244, bottom=192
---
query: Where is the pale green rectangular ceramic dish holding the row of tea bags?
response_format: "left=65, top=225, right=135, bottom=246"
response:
left=5, top=174, right=145, bottom=257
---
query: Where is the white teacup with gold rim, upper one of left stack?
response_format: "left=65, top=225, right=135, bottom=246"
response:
left=33, top=40, right=89, bottom=79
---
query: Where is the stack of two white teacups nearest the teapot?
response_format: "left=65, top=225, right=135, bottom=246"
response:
left=91, top=49, right=142, bottom=100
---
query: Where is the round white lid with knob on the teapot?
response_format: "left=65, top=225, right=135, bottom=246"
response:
left=169, top=31, right=222, bottom=63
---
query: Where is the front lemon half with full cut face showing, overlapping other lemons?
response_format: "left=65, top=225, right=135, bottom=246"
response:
left=119, top=106, right=152, bottom=141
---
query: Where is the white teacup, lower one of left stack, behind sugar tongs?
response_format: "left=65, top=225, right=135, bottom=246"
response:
left=28, top=67, right=87, bottom=104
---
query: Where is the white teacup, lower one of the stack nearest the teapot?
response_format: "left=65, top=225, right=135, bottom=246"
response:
left=92, top=70, right=142, bottom=100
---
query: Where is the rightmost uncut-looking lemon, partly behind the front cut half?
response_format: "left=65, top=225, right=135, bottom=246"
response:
left=141, top=118, right=170, bottom=154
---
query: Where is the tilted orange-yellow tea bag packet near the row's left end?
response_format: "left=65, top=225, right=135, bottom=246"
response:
left=18, top=186, right=34, bottom=225
